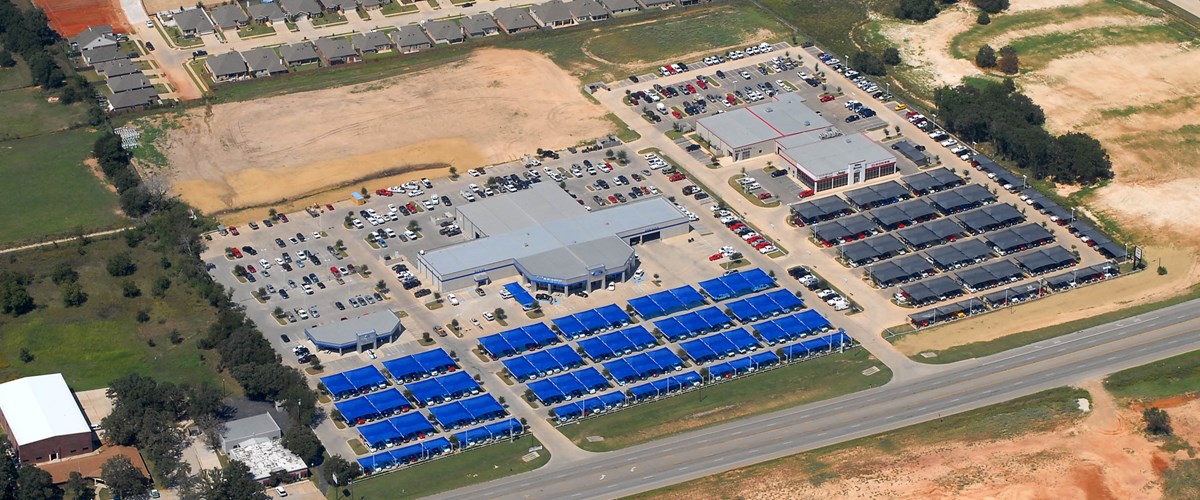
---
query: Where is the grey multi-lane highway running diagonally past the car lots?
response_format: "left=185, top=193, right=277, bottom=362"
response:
left=434, top=300, right=1200, bottom=499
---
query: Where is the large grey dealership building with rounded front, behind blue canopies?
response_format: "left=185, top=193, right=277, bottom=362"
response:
left=418, top=183, right=691, bottom=294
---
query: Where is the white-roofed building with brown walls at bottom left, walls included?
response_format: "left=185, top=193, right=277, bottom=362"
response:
left=0, top=373, right=94, bottom=463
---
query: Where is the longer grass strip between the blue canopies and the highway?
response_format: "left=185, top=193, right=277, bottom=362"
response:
left=559, top=349, right=892, bottom=451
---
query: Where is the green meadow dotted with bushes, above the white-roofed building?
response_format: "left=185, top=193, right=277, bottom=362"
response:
left=0, top=236, right=228, bottom=390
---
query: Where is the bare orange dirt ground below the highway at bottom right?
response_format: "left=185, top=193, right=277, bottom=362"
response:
left=661, top=381, right=1200, bottom=499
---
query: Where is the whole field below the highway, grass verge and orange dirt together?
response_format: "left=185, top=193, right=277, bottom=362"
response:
left=641, top=381, right=1200, bottom=499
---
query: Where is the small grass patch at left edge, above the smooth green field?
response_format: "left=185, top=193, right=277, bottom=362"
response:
left=0, top=86, right=88, bottom=140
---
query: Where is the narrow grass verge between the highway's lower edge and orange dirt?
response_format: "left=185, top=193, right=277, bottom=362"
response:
left=632, top=388, right=1087, bottom=499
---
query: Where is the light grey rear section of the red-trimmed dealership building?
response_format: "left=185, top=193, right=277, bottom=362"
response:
left=696, top=94, right=832, bottom=161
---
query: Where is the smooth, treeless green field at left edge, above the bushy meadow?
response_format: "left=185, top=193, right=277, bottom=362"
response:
left=0, top=129, right=125, bottom=246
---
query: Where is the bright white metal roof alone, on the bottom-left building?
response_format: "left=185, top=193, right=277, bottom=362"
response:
left=0, top=373, right=91, bottom=446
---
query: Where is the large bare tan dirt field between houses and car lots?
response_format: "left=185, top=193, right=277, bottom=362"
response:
left=162, top=49, right=613, bottom=213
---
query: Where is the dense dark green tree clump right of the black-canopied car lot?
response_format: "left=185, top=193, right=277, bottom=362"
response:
left=934, top=80, right=1112, bottom=185
